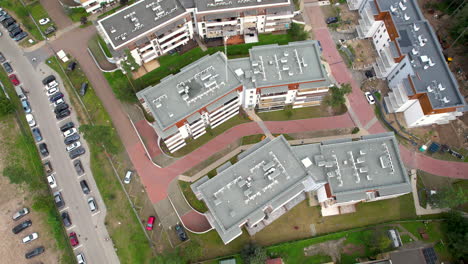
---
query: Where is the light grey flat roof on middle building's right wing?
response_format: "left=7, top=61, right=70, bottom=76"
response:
left=232, top=40, right=328, bottom=88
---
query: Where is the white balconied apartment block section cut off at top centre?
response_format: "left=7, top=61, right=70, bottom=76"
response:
left=195, top=0, right=294, bottom=39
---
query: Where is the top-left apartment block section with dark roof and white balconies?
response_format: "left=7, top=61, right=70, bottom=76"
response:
left=97, top=0, right=194, bottom=65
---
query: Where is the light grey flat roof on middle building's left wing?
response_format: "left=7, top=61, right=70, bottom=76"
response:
left=137, top=52, right=241, bottom=131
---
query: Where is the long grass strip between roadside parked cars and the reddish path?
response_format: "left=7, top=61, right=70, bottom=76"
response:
left=47, top=57, right=152, bottom=263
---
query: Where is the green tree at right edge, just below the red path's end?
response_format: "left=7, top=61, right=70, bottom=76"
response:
left=430, top=187, right=468, bottom=208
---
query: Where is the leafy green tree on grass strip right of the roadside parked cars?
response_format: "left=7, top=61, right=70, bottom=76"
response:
left=80, top=125, right=119, bottom=154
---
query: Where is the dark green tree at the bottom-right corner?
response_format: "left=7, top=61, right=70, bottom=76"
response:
left=442, top=211, right=468, bottom=260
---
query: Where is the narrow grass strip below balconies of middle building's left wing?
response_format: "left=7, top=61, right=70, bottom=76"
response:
left=166, top=114, right=251, bottom=157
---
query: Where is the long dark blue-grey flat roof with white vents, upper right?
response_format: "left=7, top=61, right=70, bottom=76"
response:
left=377, top=0, right=465, bottom=109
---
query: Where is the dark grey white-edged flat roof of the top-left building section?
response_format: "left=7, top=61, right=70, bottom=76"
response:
left=98, top=0, right=186, bottom=49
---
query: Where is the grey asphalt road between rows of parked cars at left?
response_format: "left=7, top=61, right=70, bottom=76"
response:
left=0, top=27, right=119, bottom=263
